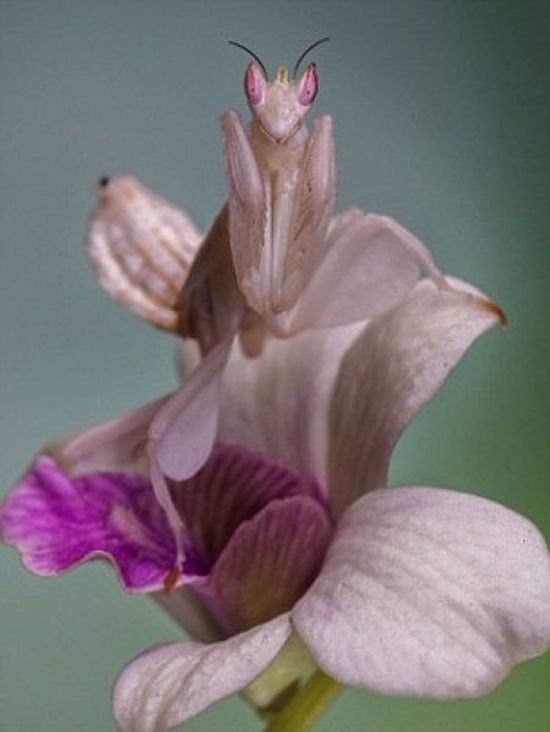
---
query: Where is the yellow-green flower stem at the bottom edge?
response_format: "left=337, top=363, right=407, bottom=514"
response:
left=265, top=671, right=342, bottom=732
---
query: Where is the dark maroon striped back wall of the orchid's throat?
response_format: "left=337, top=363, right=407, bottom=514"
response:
left=172, top=446, right=321, bottom=573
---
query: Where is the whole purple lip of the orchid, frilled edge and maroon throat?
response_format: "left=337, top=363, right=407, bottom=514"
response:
left=0, top=446, right=332, bottom=627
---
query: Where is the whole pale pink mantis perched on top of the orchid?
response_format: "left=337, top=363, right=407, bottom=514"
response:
left=83, top=39, right=447, bottom=576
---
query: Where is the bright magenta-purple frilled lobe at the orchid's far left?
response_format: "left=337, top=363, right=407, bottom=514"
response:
left=0, top=457, right=176, bottom=593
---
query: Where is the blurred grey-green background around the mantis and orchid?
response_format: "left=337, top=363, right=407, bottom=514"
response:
left=0, top=0, right=550, bottom=732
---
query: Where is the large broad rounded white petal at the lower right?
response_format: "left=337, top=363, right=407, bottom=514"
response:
left=293, top=488, right=550, bottom=699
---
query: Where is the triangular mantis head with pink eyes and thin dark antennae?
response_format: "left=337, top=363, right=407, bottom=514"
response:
left=230, top=38, right=329, bottom=143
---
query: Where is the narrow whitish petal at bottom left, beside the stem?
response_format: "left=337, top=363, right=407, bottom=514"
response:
left=113, top=614, right=291, bottom=732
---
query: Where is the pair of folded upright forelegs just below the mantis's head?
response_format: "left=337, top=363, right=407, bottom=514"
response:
left=222, top=111, right=335, bottom=316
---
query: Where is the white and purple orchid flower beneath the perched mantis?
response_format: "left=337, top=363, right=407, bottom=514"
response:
left=4, top=280, right=550, bottom=732
